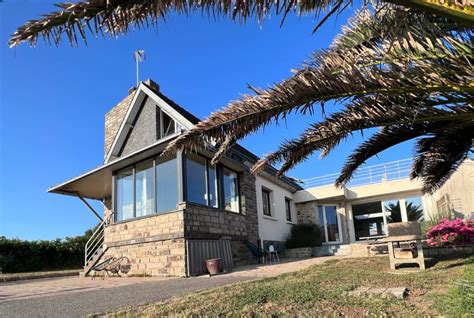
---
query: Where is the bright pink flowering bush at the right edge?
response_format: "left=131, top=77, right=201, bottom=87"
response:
left=427, top=218, right=474, bottom=246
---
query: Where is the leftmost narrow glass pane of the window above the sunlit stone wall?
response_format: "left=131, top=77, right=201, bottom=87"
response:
left=116, top=169, right=133, bottom=221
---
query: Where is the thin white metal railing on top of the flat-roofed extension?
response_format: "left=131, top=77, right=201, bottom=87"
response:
left=303, top=158, right=412, bottom=189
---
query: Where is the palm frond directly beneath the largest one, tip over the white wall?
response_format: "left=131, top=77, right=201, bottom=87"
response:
left=252, top=94, right=474, bottom=176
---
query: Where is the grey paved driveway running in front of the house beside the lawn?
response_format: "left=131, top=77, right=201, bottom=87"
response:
left=0, top=256, right=340, bottom=317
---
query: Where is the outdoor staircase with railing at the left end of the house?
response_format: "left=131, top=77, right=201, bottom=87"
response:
left=80, top=213, right=112, bottom=276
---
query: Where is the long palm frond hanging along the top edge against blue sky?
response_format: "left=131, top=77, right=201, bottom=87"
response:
left=9, top=0, right=351, bottom=47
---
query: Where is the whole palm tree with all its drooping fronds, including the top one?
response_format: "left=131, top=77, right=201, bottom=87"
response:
left=10, top=0, right=474, bottom=192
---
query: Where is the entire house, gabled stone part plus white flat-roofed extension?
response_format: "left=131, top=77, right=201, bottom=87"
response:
left=48, top=80, right=474, bottom=276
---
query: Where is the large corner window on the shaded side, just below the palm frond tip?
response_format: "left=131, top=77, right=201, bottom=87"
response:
left=185, top=154, right=240, bottom=212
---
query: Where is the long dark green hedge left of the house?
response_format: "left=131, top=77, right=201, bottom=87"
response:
left=0, top=230, right=92, bottom=273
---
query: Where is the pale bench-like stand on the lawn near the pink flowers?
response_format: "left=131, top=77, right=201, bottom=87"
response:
left=379, top=221, right=425, bottom=270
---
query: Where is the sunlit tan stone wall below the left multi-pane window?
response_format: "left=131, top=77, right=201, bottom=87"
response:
left=104, top=211, right=186, bottom=276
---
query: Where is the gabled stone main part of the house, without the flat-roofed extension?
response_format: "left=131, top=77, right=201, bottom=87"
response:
left=49, top=80, right=302, bottom=276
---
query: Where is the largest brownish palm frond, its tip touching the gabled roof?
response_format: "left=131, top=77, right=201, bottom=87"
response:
left=167, top=8, right=474, bottom=161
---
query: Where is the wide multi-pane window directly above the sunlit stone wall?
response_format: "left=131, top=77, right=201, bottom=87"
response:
left=115, top=158, right=178, bottom=221
